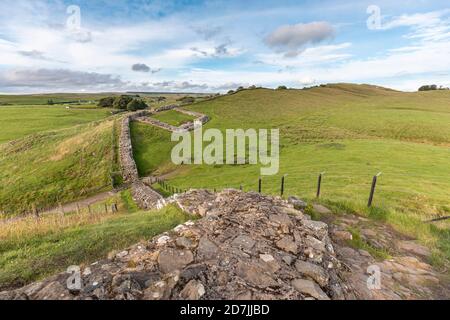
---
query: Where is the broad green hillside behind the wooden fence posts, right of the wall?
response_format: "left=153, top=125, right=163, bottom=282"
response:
left=130, top=84, right=450, bottom=266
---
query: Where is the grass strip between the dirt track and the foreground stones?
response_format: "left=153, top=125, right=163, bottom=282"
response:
left=0, top=201, right=189, bottom=291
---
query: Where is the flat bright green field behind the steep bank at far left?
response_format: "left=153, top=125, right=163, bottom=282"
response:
left=0, top=105, right=110, bottom=144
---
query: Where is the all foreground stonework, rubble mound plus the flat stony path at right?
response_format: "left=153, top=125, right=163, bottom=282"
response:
left=0, top=189, right=450, bottom=300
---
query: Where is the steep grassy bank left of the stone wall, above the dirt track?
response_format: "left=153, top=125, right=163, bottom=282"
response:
left=0, top=120, right=114, bottom=214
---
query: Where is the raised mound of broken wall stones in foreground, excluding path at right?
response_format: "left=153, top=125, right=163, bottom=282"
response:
left=0, top=190, right=347, bottom=300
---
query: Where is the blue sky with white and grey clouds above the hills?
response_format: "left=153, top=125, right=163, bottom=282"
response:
left=0, top=0, right=450, bottom=93
